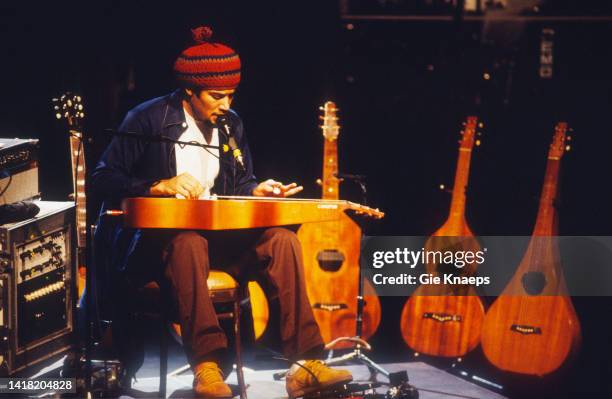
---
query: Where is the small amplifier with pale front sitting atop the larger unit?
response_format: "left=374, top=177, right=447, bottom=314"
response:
left=0, top=138, right=40, bottom=205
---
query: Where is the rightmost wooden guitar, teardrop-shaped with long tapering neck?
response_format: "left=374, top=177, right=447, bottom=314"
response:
left=482, top=122, right=581, bottom=376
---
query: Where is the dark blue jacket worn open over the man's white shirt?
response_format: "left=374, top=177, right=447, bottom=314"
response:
left=91, top=90, right=257, bottom=272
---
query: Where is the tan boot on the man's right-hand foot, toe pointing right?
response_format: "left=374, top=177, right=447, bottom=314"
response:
left=285, top=360, right=353, bottom=398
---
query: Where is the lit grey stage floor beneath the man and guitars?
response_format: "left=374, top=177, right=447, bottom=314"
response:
left=125, top=362, right=504, bottom=399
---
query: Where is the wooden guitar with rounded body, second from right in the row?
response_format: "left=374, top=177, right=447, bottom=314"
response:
left=400, top=116, right=484, bottom=357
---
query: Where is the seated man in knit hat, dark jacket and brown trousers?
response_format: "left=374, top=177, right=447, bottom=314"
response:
left=92, top=27, right=352, bottom=398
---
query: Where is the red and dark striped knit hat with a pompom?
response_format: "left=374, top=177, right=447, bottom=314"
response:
left=174, top=26, right=240, bottom=90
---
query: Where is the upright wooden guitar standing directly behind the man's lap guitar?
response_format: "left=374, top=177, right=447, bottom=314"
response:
left=297, top=101, right=382, bottom=348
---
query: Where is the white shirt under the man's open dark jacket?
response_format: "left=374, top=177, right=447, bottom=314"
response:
left=174, top=109, right=219, bottom=199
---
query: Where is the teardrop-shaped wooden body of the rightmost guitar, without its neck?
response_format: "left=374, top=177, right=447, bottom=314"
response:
left=482, top=237, right=581, bottom=376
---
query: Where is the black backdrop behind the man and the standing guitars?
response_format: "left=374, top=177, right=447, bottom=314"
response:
left=0, top=0, right=612, bottom=397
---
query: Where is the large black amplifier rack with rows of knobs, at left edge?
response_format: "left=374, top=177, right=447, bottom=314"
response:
left=0, top=201, right=76, bottom=376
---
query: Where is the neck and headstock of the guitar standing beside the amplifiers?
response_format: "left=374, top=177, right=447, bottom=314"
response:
left=53, top=92, right=87, bottom=297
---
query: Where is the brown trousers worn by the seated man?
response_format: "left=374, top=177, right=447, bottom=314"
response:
left=123, top=227, right=323, bottom=365
